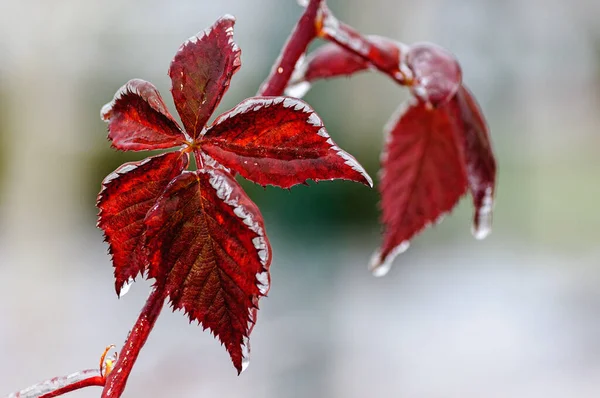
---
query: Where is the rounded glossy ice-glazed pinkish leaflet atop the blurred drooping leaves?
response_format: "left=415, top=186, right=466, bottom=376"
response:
left=406, top=43, right=462, bottom=107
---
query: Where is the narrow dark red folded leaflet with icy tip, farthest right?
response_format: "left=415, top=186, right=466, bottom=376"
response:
left=455, top=86, right=496, bottom=239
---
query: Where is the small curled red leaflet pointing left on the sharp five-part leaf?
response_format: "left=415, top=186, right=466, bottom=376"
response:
left=101, top=79, right=185, bottom=151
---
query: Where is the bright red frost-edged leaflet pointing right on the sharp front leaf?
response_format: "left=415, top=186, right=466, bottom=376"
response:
left=201, top=97, right=372, bottom=188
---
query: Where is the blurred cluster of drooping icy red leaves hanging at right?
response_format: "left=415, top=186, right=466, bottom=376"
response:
left=286, top=38, right=496, bottom=275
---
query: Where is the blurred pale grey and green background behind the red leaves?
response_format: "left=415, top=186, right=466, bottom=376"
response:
left=0, top=0, right=600, bottom=398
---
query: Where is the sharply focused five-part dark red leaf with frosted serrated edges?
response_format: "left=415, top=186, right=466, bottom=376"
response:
left=98, top=16, right=372, bottom=376
